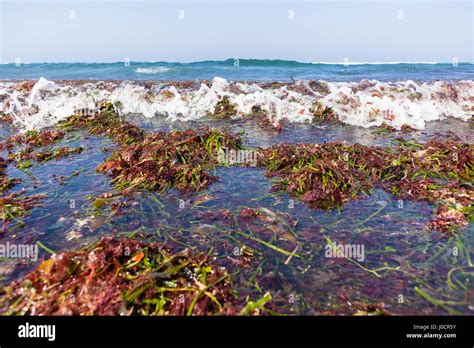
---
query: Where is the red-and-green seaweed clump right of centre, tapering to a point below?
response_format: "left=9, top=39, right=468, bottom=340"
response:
left=259, top=143, right=383, bottom=209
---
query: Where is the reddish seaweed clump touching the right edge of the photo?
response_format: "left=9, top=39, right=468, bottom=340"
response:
left=384, top=139, right=474, bottom=232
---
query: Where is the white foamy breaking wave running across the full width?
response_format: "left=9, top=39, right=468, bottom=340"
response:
left=0, top=77, right=474, bottom=129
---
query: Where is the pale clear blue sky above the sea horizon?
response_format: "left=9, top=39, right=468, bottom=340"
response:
left=0, top=0, right=474, bottom=62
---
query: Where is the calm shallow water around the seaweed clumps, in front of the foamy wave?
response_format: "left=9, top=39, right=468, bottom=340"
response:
left=0, top=116, right=474, bottom=315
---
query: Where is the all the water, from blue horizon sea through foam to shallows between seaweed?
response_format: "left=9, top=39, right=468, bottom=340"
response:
left=0, top=59, right=474, bottom=315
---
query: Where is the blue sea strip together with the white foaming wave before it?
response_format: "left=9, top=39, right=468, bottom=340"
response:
left=0, top=59, right=474, bottom=130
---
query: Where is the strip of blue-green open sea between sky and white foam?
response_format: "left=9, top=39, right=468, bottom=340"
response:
left=0, top=59, right=474, bottom=82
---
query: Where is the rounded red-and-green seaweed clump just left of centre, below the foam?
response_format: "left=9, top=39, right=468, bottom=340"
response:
left=97, top=128, right=240, bottom=191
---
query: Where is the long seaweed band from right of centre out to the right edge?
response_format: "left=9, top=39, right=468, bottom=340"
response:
left=259, top=140, right=474, bottom=232
